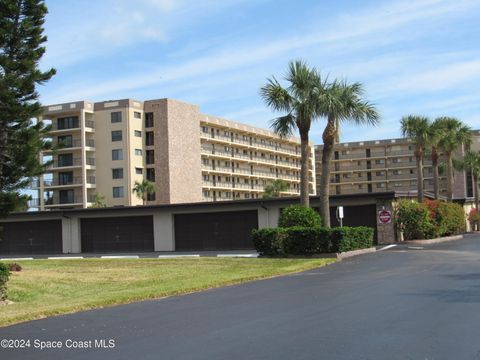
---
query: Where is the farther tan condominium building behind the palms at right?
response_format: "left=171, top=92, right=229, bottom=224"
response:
left=315, top=131, right=480, bottom=198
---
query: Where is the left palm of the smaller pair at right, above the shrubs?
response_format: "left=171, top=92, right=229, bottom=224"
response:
left=400, top=115, right=430, bottom=202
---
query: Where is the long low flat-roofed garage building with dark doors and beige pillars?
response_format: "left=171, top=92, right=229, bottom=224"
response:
left=0, top=193, right=395, bottom=255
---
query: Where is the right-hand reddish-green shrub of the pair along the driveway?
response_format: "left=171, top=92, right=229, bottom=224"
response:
left=435, top=202, right=466, bottom=236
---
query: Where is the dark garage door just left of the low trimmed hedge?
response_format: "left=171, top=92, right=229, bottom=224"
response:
left=175, top=210, right=258, bottom=250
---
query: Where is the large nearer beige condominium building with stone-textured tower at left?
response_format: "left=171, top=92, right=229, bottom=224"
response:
left=34, top=99, right=316, bottom=209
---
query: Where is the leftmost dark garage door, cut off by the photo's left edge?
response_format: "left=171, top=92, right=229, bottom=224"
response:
left=0, top=220, right=62, bottom=255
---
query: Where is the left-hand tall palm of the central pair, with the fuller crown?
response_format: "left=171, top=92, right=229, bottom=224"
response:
left=260, top=60, right=325, bottom=207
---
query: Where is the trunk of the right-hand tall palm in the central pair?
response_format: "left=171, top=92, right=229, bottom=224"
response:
left=320, top=117, right=335, bottom=228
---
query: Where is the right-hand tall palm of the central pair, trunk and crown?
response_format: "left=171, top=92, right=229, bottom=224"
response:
left=319, top=80, right=380, bottom=227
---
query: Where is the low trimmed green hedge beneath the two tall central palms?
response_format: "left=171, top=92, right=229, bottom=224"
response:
left=252, top=226, right=374, bottom=256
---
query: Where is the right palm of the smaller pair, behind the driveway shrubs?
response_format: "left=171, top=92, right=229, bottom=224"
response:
left=434, top=116, right=472, bottom=201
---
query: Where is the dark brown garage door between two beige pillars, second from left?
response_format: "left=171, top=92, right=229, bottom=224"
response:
left=81, top=216, right=154, bottom=252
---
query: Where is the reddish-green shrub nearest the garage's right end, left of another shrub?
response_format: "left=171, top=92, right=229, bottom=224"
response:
left=396, top=200, right=436, bottom=240
